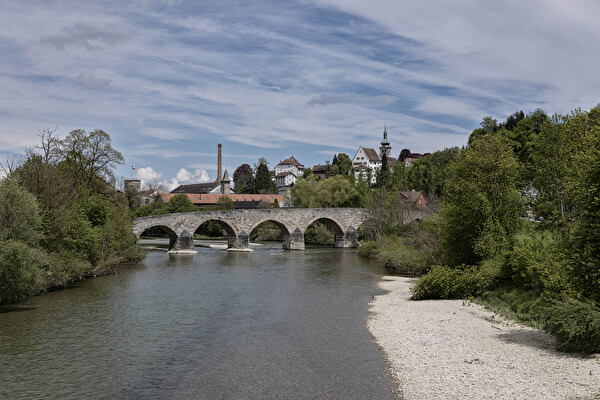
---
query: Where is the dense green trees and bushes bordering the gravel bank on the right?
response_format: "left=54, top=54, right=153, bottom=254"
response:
left=362, top=107, right=600, bottom=352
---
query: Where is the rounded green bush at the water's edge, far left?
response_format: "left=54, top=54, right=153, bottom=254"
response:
left=0, top=240, right=45, bottom=303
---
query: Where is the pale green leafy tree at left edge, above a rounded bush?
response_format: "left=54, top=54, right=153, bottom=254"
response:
left=0, top=175, right=42, bottom=246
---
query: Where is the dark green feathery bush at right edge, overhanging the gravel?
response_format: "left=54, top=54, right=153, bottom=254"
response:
left=543, top=298, right=600, bottom=353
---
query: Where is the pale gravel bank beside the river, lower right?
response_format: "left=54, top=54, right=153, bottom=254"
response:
left=368, top=276, right=600, bottom=400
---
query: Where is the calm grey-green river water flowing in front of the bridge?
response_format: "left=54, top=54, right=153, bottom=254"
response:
left=0, top=242, right=396, bottom=399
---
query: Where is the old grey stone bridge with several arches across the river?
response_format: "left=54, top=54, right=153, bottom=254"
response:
left=132, top=208, right=368, bottom=253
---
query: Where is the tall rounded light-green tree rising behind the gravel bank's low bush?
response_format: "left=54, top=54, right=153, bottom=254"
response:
left=440, top=135, right=520, bottom=266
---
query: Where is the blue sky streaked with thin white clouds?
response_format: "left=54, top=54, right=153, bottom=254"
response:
left=0, top=0, right=600, bottom=189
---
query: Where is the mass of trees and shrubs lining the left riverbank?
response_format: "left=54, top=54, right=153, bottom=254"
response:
left=0, top=129, right=143, bottom=303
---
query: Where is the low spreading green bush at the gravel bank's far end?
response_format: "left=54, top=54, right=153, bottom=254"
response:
left=411, top=263, right=497, bottom=300
